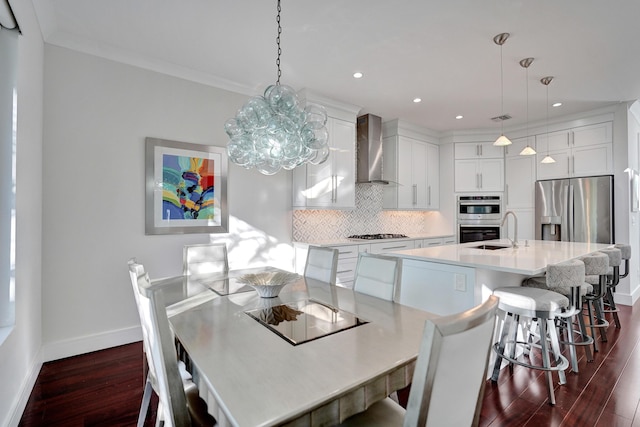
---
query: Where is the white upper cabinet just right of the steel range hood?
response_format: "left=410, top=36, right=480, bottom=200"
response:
left=382, top=135, right=440, bottom=210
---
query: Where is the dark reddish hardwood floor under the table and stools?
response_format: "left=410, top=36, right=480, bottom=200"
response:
left=20, top=302, right=640, bottom=427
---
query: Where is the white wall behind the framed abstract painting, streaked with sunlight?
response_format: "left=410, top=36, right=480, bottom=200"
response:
left=42, top=45, right=293, bottom=361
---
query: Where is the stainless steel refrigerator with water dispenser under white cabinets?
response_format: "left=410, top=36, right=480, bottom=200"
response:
left=535, top=175, right=614, bottom=243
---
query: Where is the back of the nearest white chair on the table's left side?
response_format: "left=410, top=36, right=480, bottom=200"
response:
left=137, top=273, right=191, bottom=427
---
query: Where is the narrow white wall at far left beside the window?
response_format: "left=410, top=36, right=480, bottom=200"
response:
left=0, top=1, right=44, bottom=426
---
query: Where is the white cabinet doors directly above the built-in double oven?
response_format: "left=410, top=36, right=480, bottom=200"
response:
left=454, top=142, right=504, bottom=192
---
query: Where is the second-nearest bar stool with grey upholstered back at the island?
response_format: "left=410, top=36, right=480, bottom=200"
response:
left=522, top=260, right=593, bottom=372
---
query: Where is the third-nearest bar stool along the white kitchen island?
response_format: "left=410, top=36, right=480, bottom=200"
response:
left=581, top=252, right=609, bottom=352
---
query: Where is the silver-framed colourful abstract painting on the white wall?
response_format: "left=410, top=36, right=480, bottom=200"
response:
left=145, top=137, right=229, bottom=235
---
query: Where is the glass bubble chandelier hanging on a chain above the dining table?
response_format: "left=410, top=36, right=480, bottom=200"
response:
left=224, top=0, right=329, bottom=175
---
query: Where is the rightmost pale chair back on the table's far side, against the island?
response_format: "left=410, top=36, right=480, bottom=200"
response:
left=353, top=252, right=402, bottom=301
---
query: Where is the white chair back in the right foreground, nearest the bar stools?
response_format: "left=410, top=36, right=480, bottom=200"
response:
left=404, top=296, right=498, bottom=427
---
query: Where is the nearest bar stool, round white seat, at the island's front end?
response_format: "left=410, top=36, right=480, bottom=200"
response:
left=491, top=286, right=569, bottom=405
